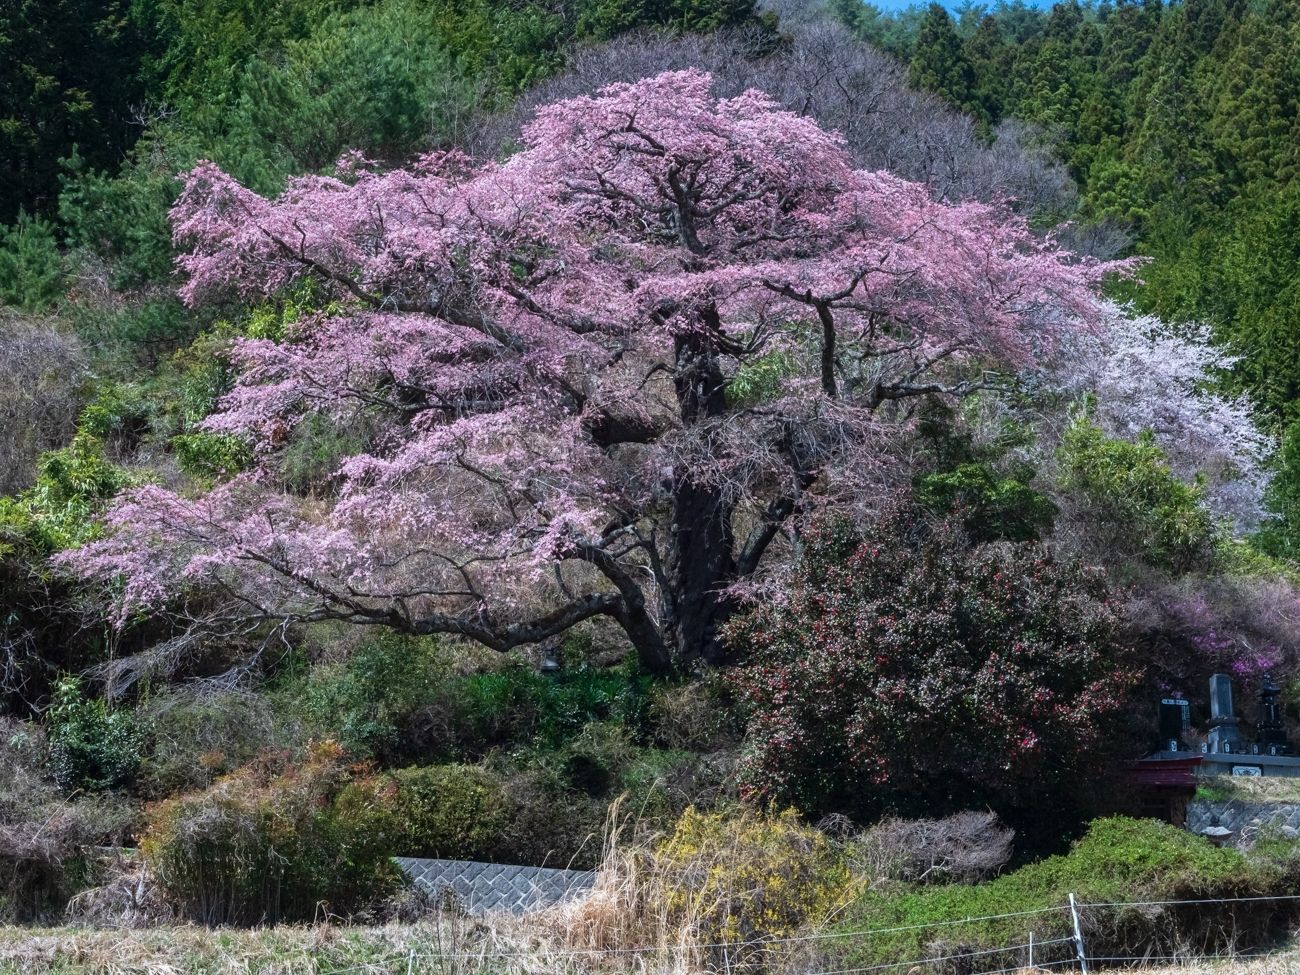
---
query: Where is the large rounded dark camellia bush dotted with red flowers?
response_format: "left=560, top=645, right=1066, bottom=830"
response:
left=731, top=504, right=1139, bottom=837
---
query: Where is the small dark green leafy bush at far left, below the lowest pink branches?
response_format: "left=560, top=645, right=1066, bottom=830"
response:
left=46, top=677, right=140, bottom=792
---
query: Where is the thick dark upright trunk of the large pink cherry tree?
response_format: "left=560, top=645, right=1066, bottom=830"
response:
left=664, top=308, right=736, bottom=663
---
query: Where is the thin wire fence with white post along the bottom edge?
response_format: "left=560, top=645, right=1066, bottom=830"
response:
left=316, top=894, right=1300, bottom=975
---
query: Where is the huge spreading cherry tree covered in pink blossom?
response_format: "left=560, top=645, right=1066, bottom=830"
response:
left=68, top=70, right=1117, bottom=672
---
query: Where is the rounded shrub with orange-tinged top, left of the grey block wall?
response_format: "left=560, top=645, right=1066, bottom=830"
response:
left=140, top=742, right=398, bottom=924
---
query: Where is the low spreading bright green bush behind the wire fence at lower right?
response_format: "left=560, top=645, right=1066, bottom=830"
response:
left=835, top=818, right=1300, bottom=969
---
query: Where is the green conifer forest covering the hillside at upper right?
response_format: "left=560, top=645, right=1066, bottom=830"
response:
left=835, top=0, right=1300, bottom=551
